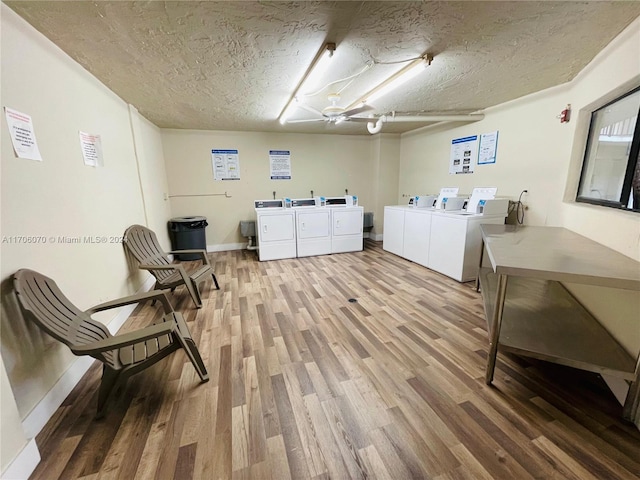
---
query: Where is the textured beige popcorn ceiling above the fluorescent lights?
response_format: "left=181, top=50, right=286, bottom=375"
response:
left=5, top=1, right=640, bottom=134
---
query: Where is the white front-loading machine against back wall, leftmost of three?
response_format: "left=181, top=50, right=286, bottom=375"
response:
left=254, top=200, right=297, bottom=262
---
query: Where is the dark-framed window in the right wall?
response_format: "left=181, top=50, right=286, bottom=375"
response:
left=576, top=88, right=640, bottom=212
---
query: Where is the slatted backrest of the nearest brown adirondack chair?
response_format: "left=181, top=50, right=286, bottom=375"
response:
left=13, top=269, right=114, bottom=365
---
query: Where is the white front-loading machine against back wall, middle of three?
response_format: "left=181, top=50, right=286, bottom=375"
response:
left=291, top=198, right=331, bottom=257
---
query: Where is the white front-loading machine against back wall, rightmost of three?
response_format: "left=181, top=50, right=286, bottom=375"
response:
left=326, top=195, right=364, bottom=253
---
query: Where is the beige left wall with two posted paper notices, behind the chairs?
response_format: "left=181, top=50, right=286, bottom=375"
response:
left=0, top=4, right=169, bottom=470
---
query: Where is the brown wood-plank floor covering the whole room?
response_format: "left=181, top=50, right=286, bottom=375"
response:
left=32, top=241, right=640, bottom=480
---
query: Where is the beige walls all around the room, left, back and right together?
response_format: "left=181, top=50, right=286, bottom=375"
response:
left=5, top=5, right=640, bottom=470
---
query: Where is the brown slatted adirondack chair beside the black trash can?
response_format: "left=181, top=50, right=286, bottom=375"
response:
left=124, top=225, right=220, bottom=308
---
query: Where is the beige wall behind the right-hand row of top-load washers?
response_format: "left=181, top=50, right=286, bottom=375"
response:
left=398, top=87, right=572, bottom=225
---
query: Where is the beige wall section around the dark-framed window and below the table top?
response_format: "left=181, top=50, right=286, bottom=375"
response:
left=559, top=15, right=640, bottom=368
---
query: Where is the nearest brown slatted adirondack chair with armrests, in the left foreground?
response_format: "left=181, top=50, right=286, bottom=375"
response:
left=13, top=269, right=209, bottom=418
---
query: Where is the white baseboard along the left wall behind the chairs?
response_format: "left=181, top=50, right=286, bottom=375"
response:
left=22, top=275, right=155, bottom=438
